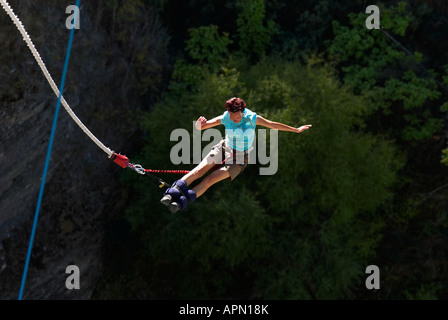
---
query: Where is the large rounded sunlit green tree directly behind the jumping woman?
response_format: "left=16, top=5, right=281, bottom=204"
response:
left=120, top=59, right=401, bottom=299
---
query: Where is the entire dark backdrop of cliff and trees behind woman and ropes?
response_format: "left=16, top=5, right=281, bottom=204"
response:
left=0, top=0, right=448, bottom=300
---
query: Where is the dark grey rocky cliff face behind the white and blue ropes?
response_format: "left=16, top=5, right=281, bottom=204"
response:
left=0, top=0, right=165, bottom=299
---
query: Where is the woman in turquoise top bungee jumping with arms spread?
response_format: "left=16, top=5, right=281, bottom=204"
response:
left=160, top=97, right=311, bottom=213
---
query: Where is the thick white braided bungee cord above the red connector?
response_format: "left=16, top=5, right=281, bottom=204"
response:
left=0, top=0, right=114, bottom=157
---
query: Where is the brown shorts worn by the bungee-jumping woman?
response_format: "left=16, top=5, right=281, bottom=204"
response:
left=205, top=139, right=249, bottom=181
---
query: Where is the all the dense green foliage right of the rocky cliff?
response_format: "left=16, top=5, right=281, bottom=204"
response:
left=92, top=0, right=448, bottom=299
